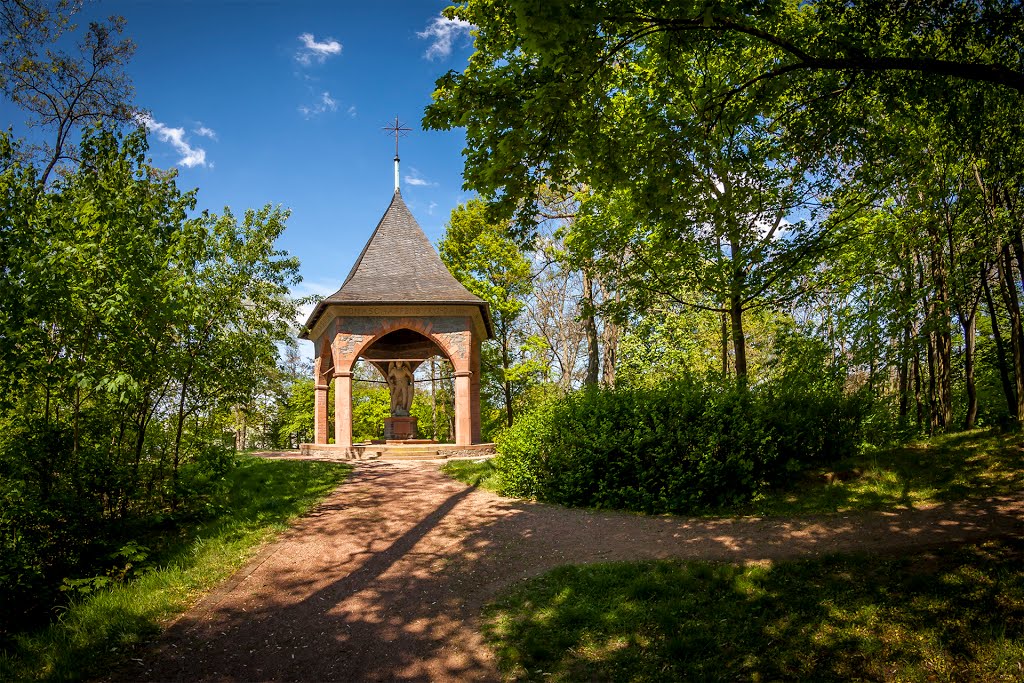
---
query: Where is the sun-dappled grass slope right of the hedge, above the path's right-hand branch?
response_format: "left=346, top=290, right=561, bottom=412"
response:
left=741, top=429, right=1024, bottom=516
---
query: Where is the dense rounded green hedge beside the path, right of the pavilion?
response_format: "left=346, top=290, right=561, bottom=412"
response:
left=494, top=378, right=861, bottom=513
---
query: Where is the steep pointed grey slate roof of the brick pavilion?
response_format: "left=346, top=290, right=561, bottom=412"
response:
left=303, top=189, right=490, bottom=338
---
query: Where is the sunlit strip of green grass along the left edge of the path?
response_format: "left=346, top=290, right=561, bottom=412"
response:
left=0, top=458, right=350, bottom=681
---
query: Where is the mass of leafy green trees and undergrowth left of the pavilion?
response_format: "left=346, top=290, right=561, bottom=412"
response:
left=0, top=129, right=298, bottom=633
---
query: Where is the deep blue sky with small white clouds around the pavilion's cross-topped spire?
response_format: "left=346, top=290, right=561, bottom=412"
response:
left=0, top=0, right=472, bottom=333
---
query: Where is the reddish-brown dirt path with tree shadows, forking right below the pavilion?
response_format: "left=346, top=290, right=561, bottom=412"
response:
left=117, top=462, right=1024, bottom=681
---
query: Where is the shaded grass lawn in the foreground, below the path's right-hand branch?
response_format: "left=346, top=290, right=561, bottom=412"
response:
left=484, top=540, right=1024, bottom=681
